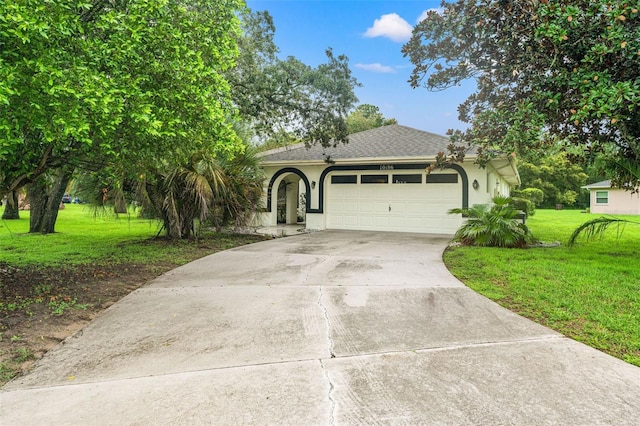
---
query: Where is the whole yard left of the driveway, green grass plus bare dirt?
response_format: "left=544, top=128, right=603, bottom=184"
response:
left=0, top=204, right=265, bottom=386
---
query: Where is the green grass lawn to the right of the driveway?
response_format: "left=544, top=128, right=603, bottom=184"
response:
left=444, top=210, right=640, bottom=366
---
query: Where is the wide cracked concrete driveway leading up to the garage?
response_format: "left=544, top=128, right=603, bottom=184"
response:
left=0, top=231, right=640, bottom=425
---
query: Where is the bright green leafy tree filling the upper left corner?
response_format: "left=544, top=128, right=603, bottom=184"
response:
left=0, top=0, right=244, bottom=232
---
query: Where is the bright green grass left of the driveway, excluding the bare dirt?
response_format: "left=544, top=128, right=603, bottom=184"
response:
left=0, top=204, right=258, bottom=266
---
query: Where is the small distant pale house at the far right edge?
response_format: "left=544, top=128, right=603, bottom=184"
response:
left=582, top=180, right=640, bottom=214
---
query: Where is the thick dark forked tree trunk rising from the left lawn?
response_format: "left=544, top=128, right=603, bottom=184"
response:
left=29, top=168, right=73, bottom=234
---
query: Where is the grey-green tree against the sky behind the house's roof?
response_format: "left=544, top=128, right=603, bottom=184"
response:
left=227, top=11, right=358, bottom=146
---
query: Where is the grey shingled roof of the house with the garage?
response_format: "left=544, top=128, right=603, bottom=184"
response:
left=262, top=124, right=464, bottom=162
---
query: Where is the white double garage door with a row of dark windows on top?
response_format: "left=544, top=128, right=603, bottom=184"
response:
left=325, top=172, right=462, bottom=234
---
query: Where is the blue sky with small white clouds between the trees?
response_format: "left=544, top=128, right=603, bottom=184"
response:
left=247, top=0, right=475, bottom=134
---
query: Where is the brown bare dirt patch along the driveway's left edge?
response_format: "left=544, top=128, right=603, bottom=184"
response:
left=0, top=236, right=264, bottom=386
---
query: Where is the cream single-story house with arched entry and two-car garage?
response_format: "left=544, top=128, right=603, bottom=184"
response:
left=257, top=125, right=520, bottom=234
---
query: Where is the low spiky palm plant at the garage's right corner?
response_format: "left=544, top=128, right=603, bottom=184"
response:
left=449, top=196, right=533, bottom=248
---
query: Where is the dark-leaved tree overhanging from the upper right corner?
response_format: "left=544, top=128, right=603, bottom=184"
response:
left=403, top=0, right=640, bottom=187
